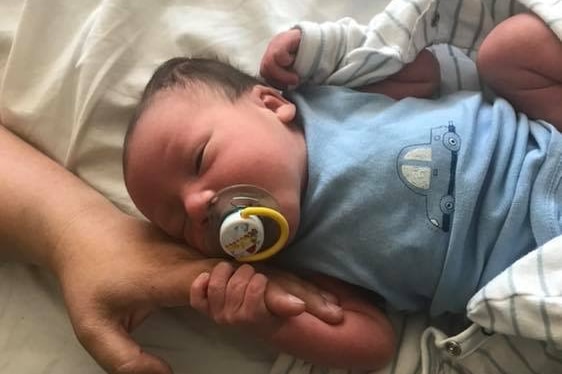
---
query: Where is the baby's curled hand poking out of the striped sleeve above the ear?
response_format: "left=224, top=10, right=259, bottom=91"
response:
left=260, top=29, right=301, bottom=89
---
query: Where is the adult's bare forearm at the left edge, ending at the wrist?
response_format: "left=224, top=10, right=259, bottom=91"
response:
left=0, top=125, right=117, bottom=268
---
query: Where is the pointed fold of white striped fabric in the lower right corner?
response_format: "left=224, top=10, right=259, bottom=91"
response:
left=467, top=237, right=562, bottom=349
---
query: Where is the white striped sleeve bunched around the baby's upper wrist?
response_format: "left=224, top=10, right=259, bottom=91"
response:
left=294, top=9, right=427, bottom=87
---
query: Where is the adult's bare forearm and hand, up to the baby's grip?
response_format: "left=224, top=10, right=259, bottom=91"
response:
left=0, top=126, right=225, bottom=373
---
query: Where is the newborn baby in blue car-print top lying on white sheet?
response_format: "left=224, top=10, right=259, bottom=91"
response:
left=124, top=14, right=562, bottom=369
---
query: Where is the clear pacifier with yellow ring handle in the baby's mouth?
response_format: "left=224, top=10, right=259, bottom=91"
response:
left=207, top=184, right=289, bottom=262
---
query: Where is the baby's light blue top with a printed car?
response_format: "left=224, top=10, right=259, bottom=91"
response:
left=276, top=86, right=562, bottom=315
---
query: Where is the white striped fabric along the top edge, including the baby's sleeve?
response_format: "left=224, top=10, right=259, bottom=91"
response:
left=295, top=0, right=562, bottom=93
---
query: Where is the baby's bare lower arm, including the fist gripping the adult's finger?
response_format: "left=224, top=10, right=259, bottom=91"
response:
left=191, top=263, right=395, bottom=370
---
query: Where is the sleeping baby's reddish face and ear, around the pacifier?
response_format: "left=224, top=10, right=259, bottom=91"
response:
left=126, top=86, right=306, bottom=256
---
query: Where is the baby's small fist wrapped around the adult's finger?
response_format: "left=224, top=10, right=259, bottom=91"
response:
left=190, top=262, right=298, bottom=336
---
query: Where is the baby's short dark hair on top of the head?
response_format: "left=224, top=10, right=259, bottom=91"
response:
left=123, top=57, right=263, bottom=177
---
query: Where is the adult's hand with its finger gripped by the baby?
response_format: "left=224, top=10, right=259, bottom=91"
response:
left=55, top=211, right=343, bottom=374
